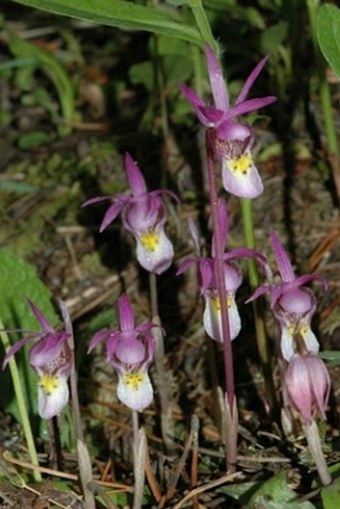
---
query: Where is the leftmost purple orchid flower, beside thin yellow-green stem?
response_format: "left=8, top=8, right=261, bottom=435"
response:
left=2, top=300, right=73, bottom=419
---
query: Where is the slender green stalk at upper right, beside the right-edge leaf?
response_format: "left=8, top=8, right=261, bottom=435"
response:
left=306, top=0, right=340, bottom=193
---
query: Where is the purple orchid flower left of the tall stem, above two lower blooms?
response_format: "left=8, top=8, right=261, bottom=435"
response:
left=83, top=154, right=178, bottom=274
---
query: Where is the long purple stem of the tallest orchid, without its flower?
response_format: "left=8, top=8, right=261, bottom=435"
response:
left=206, top=129, right=237, bottom=472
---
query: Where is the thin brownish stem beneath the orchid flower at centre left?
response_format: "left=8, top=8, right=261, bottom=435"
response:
left=149, top=272, right=173, bottom=450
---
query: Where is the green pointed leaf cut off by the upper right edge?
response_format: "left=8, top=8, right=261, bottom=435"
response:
left=316, top=4, right=340, bottom=77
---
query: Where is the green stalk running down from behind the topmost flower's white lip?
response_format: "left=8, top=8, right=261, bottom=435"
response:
left=241, top=198, right=278, bottom=413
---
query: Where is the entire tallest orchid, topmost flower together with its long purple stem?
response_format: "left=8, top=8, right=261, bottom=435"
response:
left=180, top=45, right=276, bottom=469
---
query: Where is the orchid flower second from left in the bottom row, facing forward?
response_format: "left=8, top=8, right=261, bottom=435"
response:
left=88, top=295, right=157, bottom=412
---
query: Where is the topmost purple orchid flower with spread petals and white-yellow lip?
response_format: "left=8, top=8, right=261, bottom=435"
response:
left=180, top=45, right=276, bottom=198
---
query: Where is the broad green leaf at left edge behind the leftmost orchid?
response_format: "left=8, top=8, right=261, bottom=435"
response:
left=0, top=248, right=58, bottom=419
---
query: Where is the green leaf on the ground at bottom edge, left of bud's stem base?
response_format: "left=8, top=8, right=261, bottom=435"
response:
left=246, top=471, right=315, bottom=509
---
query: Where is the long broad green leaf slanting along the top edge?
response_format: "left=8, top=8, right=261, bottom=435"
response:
left=15, top=0, right=203, bottom=44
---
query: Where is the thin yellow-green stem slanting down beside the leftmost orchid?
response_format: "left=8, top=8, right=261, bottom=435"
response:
left=0, top=320, right=42, bottom=482
